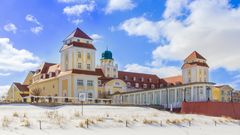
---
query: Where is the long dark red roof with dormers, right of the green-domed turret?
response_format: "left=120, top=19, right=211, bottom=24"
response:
left=118, top=71, right=159, bottom=89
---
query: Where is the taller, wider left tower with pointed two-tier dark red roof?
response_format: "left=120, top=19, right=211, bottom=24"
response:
left=60, top=28, right=96, bottom=71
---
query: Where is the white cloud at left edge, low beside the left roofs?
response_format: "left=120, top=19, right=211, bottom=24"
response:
left=0, top=38, right=40, bottom=75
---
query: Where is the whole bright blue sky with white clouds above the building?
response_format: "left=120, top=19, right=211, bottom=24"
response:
left=0, top=0, right=240, bottom=93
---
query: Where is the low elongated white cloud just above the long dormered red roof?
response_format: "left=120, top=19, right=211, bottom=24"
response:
left=124, top=64, right=181, bottom=77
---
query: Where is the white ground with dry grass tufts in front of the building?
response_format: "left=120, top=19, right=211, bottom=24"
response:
left=0, top=104, right=240, bottom=135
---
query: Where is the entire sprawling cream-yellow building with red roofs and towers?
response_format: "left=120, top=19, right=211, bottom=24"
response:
left=6, top=28, right=234, bottom=107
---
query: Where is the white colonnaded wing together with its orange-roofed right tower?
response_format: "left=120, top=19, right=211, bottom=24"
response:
left=112, top=51, right=214, bottom=108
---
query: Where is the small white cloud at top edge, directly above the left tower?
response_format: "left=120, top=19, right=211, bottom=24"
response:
left=63, top=1, right=95, bottom=16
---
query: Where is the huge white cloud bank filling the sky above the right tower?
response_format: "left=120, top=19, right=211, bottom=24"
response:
left=120, top=0, right=240, bottom=71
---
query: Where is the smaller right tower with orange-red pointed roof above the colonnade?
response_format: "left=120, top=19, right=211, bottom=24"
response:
left=182, top=51, right=209, bottom=84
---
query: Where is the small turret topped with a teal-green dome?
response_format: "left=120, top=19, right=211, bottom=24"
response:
left=100, top=49, right=118, bottom=78
